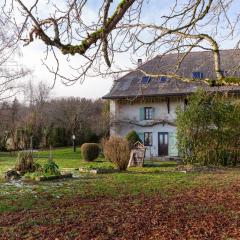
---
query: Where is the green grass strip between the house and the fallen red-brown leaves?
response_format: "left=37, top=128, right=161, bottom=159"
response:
left=0, top=148, right=239, bottom=212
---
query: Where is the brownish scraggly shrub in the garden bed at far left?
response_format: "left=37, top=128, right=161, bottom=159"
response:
left=15, top=152, right=35, bottom=174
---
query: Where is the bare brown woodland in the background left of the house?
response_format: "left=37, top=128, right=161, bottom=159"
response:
left=0, top=82, right=109, bottom=151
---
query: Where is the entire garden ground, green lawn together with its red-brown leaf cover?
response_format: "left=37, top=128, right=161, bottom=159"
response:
left=0, top=148, right=240, bottom=239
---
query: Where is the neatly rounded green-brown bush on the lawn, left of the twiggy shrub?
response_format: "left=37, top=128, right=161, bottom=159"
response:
left=81, top=143, right=100, bottom=162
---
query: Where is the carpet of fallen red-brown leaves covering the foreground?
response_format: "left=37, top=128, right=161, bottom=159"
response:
left=0, top=183, right=240, bottom=240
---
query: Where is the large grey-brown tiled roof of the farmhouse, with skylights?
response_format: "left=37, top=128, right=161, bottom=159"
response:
left=103, top=50, right=240, bottom=99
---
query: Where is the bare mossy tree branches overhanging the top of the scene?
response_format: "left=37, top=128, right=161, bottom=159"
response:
left=3, top=0, right=240, bottom=85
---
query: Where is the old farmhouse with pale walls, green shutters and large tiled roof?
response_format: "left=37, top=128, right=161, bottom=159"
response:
left=104, top=50, right=240, bottom=158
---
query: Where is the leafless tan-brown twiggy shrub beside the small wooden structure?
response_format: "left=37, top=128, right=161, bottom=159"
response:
left=103, top=136, right=130, bottom=171
